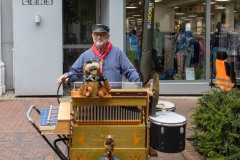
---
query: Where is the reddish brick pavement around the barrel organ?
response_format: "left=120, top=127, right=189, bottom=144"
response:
left=0, top=96, right=204, bottom=160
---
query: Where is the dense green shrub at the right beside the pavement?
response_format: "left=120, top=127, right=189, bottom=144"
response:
left=191, top=89, right=240, bottom=160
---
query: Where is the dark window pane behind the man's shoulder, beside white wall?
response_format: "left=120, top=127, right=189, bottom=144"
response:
left=63, top=0, right=97, bottom=72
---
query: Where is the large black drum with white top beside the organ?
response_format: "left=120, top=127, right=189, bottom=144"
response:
left=149, top=112, right=187, bottom=153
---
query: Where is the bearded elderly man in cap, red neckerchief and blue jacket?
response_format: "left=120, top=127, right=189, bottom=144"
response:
left=57, top=24, right=140, bottom=85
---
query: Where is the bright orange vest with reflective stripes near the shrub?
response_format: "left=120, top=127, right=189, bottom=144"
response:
left=215, top=59, right=235, bottom=91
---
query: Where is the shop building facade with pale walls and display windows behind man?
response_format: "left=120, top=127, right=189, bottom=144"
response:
left=0, top=0, right=240, bottom=96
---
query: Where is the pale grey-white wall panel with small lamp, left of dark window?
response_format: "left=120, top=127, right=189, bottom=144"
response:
left=13, top=0, right=63, bottom=96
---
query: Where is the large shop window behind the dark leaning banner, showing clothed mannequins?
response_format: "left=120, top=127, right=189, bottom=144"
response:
left=126, top=0, right=206, bottom=80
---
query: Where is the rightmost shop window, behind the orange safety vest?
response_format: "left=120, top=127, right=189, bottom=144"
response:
left=210, top=0, right=240, bottom=84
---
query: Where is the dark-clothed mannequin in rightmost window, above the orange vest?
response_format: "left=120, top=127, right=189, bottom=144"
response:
left=211, top=22, right=228, bottom=78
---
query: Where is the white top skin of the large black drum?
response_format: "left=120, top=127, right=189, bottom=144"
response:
left=149, top=112, right=186, bottom=126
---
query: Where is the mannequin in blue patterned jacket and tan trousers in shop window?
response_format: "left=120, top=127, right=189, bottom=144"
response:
left=175, top=23, right=193, bottom=79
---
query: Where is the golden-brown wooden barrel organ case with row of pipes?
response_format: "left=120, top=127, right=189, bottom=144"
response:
left=69, top=89, right=149, bottom=160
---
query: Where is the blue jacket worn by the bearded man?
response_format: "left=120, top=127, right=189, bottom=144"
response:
left=67, top=46, right=140, bottom=82
